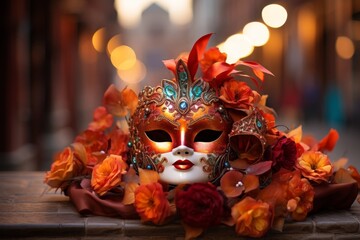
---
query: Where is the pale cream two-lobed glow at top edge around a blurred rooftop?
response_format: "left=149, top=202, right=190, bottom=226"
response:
left=115, top=0, right=193, bottom=28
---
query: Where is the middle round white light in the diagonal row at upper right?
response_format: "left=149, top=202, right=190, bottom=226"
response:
left=243, top=22, right=270, bottom=47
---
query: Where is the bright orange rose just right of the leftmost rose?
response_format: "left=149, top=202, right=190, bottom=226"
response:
left=91, top=155, right=128, bottom=196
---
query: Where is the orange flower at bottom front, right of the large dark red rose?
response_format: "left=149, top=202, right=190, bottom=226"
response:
left=231, top=197, right=272, bottom=237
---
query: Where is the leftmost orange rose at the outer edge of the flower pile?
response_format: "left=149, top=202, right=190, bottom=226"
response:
left=45, top=145, right=86, bottom=190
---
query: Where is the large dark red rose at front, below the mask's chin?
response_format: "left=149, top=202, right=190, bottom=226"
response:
left=175, top=183, right=224, bottom=228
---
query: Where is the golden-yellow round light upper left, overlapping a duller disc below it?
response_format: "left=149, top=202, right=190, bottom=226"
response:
left=110, top=45, right=136, bottom=70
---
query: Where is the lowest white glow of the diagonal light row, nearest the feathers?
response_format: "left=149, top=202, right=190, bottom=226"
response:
left=219, top=33, right=254, bottom=64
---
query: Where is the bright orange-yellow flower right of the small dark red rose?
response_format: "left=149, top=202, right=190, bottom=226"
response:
left=295, top=151, right=333, bottom=183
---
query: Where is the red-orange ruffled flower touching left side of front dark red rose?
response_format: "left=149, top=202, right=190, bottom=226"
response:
left=134, top=182, right=171, bottom=224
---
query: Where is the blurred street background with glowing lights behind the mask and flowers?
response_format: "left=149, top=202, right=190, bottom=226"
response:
left=0, top=0, right=360, bottom=170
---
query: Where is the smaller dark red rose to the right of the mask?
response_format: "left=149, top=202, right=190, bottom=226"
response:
left=272, top=137, right=297, bottom=170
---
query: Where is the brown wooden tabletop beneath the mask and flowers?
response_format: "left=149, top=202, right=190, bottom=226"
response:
left=0, top=172, right=360, bottom=240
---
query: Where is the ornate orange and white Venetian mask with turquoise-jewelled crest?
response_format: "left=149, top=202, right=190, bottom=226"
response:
left=129, top=60, right=232, bottom=185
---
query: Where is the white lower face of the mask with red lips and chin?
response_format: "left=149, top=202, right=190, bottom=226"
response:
left=159, top=145, right=210, bottom=185
